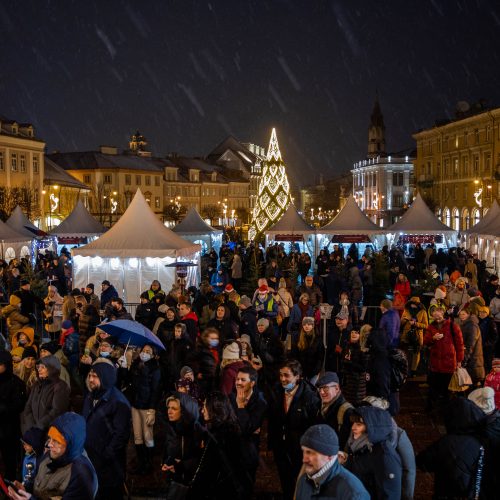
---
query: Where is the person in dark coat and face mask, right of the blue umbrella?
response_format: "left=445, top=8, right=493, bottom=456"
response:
left=186, top=328, right=221, bottom=394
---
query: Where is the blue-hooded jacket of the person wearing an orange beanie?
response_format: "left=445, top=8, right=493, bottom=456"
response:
left=33, top=413, right=97, bottom=500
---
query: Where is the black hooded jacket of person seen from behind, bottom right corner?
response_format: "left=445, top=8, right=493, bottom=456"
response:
left=417, top=398, right=486, bottom=498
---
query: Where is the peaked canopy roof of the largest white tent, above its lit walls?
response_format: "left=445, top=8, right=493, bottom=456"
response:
left=72, top=189, right=200, bottom=258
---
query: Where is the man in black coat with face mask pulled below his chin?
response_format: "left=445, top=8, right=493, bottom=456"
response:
left=268, top=359, right=320, bottom=500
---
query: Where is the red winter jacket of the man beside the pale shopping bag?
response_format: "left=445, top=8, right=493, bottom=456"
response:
left=424, top=319, right=464, bottom=373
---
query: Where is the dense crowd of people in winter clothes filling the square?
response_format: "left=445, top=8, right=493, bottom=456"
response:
left=0, top=244, right=500, bottom=500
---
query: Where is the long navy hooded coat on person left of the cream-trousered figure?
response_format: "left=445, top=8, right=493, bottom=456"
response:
left=82, top=361, right=131, bottom=487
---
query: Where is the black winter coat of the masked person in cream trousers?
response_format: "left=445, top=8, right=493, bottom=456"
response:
left=128, top=358, right=161, bottom=410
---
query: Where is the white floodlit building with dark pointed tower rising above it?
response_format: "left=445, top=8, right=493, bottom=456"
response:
left=351, top=99, right=415, bottom=227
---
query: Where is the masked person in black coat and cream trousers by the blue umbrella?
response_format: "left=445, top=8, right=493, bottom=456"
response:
left=127, top=344, right=161, bottom=474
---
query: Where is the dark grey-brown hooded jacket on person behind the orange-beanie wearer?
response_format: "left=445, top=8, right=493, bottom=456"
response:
left=21, top=355, right=70, bottom=432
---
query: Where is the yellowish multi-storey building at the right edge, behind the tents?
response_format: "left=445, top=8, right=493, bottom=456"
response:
left=413, top=106, right=500, bottom=230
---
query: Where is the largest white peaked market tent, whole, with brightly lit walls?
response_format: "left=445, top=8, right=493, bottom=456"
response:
left=71, top=189, right=200, bottom=302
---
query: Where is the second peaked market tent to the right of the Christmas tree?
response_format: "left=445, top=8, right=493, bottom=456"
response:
left=318, top=195, right=386, bottom=247
